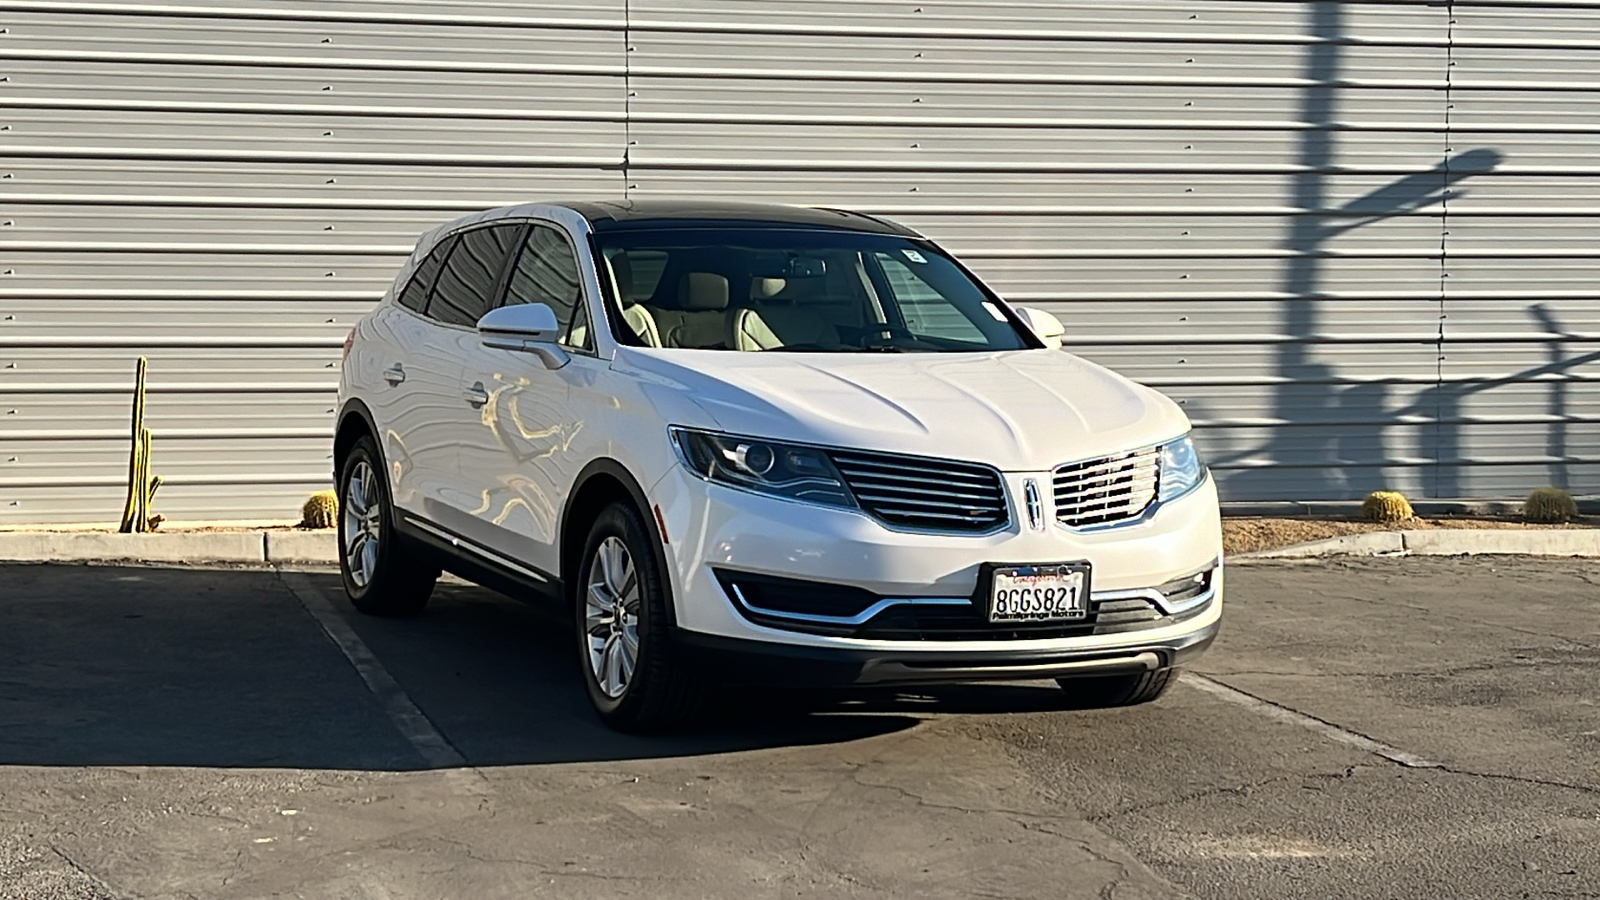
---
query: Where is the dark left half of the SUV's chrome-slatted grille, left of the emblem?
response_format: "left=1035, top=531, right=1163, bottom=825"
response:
left=829, top=450, right=1010, bottom=532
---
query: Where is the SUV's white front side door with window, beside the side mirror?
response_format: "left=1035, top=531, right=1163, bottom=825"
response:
left=461, top=223, right=600, bottom=573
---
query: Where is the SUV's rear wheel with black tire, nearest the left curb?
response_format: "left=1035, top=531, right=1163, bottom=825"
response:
left=339, top=436, right=438, bottom=615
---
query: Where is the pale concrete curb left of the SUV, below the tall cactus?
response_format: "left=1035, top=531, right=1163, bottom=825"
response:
left=0, top=532, right=339, bottom=565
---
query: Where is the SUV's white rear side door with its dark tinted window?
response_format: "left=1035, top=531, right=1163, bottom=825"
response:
left=405, top=223, right=525, bottom=533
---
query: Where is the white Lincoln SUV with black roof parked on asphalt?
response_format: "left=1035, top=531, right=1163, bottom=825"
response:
left=334, top=202, right=1222, bottom=730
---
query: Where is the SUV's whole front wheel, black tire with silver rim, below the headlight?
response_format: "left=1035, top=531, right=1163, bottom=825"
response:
left=571, top=503, right=702, bottom=733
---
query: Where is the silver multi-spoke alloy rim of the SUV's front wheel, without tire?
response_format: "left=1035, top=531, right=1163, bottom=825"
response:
left=584, top=536, right=640, bottom=700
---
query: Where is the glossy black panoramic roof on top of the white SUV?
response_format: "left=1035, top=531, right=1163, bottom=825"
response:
left=557, top=200, right=922, bottom=237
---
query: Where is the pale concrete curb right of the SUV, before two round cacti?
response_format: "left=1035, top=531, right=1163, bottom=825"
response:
left=1229, top=528, right=1600, bottom=560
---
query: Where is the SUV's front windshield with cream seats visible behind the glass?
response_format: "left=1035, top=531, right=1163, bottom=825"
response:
left=595, top=227, right=1034, bottom=352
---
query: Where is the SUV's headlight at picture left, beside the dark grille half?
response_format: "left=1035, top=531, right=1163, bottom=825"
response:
left=670, top=428, right=856, bottom=509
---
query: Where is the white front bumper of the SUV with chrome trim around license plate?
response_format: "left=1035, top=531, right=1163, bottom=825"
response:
left=650, top=468, right=1222, bottom=666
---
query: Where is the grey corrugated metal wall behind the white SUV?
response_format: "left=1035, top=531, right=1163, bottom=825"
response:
left=0, top=0, right=1600, bottom=522
